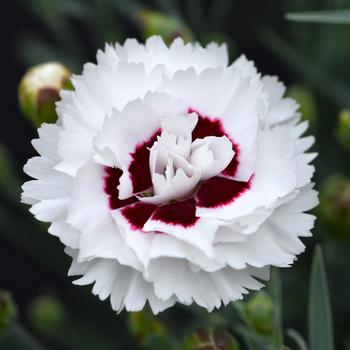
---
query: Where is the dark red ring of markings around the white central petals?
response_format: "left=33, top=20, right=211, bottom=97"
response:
left=104, top=108, right=251, bottom=231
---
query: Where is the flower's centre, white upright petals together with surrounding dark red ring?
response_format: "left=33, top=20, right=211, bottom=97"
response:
left=104, top=109, right=250, bottom=232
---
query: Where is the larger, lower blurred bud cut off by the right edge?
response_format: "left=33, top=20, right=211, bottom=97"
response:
left=319, top=175, right=350, bottom=238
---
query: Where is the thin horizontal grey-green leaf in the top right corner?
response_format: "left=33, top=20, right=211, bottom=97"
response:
left=285, top=10, right=350, bottom=24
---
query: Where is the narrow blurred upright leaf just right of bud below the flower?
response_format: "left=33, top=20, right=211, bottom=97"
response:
left=267, top=268, right=283, bottom=347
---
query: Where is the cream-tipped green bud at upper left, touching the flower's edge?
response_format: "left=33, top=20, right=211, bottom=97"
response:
left=18, top=62, right=72, bottom=127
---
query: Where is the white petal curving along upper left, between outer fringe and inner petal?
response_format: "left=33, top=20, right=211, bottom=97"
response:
left=57, top=62, right=163, bottom=175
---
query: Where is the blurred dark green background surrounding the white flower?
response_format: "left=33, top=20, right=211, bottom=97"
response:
left=0, top=0, right=350, bottom=350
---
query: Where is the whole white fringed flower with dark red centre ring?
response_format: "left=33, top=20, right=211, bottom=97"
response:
left=22, top=37, right=318, bottom=313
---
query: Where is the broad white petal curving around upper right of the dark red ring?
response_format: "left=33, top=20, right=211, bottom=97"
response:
left=158, top=67, right=265, bottom=181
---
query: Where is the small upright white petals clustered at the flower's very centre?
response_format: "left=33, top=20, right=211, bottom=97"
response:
left=139, top=113, right=234, bottom=204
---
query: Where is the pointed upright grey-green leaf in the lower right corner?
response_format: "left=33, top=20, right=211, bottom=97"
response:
left=309, top=246, right=334, bottom=350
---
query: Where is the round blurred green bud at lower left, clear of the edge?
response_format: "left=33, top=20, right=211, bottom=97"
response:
left=29, top=295, right=67, bottom=336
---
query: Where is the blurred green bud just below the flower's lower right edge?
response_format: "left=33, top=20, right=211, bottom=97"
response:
left=244, top=292, right=275, bottom=335
